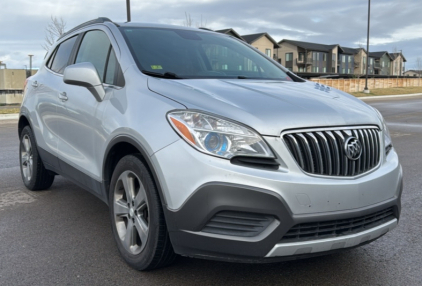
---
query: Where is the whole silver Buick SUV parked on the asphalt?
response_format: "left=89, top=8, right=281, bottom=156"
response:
left=19, top=18, right=402, bottom=270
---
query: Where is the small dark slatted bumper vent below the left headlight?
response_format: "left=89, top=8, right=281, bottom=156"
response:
left=202, top=211, right=275, bottom=237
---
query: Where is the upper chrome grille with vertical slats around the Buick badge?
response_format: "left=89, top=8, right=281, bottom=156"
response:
left=283, top=128, right=380, bottom=176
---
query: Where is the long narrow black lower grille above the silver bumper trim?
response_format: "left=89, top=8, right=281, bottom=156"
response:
left=281, top=207, right=395, bottom=243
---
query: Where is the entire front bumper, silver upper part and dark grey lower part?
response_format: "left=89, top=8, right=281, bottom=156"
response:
left=152, top=138, right=402, bottom=262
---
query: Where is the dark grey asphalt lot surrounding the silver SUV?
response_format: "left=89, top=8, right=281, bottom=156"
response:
left=0, top=96, right=422, bottom=286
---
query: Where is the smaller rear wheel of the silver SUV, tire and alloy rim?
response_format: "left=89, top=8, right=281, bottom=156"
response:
left=19, top=126, right=55, bottom=191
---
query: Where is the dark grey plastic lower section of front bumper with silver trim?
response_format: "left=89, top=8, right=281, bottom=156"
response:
left=165, top=182, right=400, bottom=263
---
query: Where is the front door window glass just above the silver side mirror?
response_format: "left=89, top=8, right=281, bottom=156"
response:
left=75, top=31, right=111, bottom=81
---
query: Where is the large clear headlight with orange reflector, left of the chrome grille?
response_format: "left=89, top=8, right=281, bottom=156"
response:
left=167, top=111, right=274, bottom=159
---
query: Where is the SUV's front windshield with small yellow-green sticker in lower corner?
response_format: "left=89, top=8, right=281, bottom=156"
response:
left=120, top=27, right=290, bottom=80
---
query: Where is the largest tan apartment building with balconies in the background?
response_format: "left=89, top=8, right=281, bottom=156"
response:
left=275, top=39, right=342, bottom=74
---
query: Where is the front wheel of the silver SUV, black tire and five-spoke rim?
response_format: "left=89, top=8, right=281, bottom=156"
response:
left=109, top=154, right=176, bottom=270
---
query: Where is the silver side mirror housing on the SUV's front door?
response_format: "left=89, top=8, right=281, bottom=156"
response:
left=63, top=62, right=105, bottom=101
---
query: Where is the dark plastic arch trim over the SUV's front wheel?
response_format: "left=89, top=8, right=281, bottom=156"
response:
left=102, top=135, right=167, bottom=206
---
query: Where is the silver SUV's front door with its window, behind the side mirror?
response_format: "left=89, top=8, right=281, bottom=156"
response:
left=58, top=30, right=121, bottom=193
